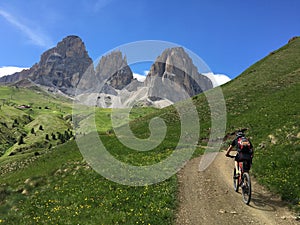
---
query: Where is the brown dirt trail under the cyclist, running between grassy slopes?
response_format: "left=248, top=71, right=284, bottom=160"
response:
left=176, top=152, right=300, bottom=225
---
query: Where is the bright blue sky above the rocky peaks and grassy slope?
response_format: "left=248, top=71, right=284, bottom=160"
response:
left=0, top=0, right=300, bottom=81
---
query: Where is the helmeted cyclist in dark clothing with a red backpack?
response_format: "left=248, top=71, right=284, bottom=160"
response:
left=225, top=131, right=253, bottom=176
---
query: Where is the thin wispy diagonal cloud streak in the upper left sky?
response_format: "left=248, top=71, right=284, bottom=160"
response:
left=0, top=9, right=52, bottom=48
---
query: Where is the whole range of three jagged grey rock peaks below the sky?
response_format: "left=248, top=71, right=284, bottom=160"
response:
left=0, top=35, right=213, bottom=107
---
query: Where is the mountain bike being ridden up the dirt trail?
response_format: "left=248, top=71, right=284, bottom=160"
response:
left=228, top=155, right=251, bottom=205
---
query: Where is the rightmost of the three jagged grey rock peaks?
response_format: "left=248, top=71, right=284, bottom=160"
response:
left=145, top=47, right=213, bottom=101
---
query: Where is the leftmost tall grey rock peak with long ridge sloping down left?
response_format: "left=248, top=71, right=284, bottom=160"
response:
left=0, top=36, right=93, bottom=95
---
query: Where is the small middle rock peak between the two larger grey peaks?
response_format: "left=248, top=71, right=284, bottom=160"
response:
left=96, top=51, right=133, bottom=90
